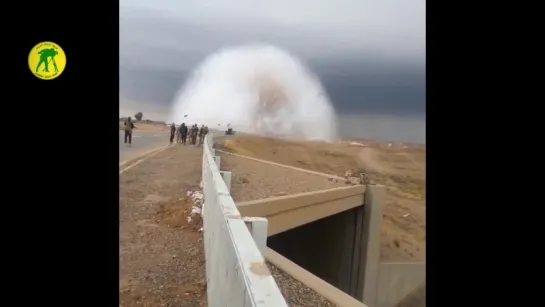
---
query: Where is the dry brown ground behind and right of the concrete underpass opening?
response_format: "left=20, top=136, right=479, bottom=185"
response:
left=217, top=135, right=426, bottom=261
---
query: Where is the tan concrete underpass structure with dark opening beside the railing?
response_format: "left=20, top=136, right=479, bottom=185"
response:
left=246, top=185, right=426, bottom=307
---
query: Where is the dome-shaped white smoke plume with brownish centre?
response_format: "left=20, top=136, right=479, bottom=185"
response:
left=172, top=45, right=337, bottom=140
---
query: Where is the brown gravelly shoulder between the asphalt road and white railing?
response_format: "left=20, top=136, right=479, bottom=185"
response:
left=119, top=145, right=206, bottom=307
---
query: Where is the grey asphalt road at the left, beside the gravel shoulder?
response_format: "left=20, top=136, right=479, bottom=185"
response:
left=119, top=130, right=170, bottom=162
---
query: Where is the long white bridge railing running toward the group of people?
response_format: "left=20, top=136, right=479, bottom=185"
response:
left=202, top=133, right=287, bottom=307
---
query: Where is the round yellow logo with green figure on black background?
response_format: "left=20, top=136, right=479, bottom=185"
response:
left=28, top=42, right=66, bottom=80
